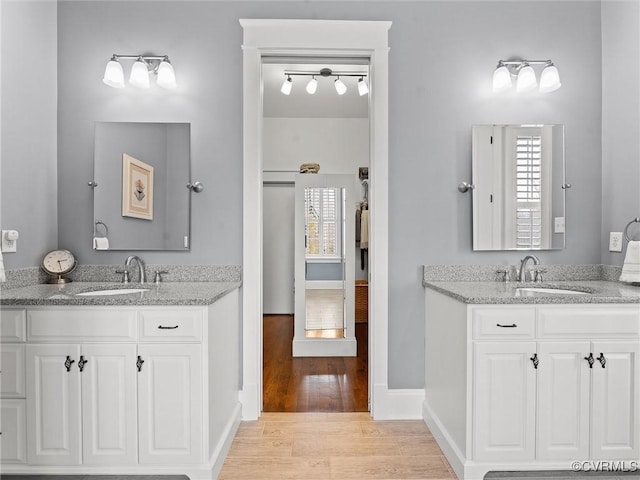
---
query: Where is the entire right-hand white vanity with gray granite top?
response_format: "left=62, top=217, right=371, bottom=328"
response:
left=423, top=274, right=640, bottom=479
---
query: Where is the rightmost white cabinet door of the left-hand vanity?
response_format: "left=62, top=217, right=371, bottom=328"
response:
left=138, top=344, right=203, bottom=464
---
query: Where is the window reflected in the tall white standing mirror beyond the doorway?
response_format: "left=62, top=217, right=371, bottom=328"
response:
left=304, top=188, right=340, bottom=257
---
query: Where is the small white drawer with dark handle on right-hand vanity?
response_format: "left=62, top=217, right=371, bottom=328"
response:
left=471, top=307, right=536, bottom=340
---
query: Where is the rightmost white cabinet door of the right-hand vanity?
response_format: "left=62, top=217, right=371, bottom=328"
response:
left=591, top=340, right=640, bottom=460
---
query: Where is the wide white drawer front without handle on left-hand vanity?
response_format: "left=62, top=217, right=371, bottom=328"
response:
left=27, top=308, right=138, bottom=342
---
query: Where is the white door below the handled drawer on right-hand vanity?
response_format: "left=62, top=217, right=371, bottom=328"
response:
left=473, top=342, right=536, bottom=461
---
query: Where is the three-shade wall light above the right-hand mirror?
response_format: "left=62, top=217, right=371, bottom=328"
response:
left=493, top=60, right=562, bottom=93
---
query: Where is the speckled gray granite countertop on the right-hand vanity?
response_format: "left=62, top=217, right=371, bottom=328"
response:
left=423, top=280, right=640, bottom=308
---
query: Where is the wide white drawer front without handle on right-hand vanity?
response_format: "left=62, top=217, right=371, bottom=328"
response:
left=538, top=305, right=640, bottom=339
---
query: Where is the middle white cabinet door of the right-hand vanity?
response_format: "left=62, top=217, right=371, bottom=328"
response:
left=536, top=342, right=590, bottom=460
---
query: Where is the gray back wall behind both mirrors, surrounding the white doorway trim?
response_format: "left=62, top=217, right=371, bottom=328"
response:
left=3, top=1, right=638, bottom=388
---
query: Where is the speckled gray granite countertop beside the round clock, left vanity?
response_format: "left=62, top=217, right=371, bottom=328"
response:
left=0, top=281, right=241, bottom=306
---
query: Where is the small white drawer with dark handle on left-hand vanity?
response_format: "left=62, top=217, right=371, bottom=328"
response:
left=140, top=309, right=202, bottom=342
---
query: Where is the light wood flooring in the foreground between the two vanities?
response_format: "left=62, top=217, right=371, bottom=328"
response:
left=218, top=413, right=456, bottom=480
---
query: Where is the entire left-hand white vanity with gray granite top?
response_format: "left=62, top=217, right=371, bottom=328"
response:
left=0, top=282, right=241, bottom=479
